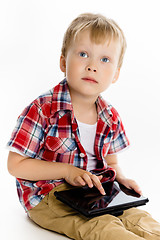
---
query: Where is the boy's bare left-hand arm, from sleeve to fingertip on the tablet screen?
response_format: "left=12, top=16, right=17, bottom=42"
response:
left=8, top=152, right=105, bottom=195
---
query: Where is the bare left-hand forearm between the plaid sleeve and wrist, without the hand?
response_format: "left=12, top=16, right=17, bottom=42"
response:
left=8, top=152, right=68, bottom=181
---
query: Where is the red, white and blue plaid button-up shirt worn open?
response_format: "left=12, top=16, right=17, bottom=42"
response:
left=8, top=79, right=129, bottom=211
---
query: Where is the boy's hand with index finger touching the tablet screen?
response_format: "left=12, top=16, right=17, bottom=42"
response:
left=64, top=165, right=105, bottom=195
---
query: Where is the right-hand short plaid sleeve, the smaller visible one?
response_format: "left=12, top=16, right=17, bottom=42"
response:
left=107, top=119, right=130, bottom=154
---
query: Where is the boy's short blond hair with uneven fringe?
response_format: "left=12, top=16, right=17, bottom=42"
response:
left=61, top=13, right=126, bottom=67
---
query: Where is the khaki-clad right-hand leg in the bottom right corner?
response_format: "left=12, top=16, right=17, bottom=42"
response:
left=119, top=208, right=160, bottom=240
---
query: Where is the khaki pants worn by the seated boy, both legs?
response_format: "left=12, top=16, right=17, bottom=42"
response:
left=29, top=184, right=160, bottom=240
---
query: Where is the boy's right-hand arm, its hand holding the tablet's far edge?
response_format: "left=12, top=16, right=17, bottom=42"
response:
left=105, top=155, right=142, bottom=195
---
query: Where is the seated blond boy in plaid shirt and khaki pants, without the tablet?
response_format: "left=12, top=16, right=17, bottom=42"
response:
left=8, top=14, right=160, bottom=240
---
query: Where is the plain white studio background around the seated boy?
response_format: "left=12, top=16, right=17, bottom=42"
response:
left=0, top=0, right=160, bottom=240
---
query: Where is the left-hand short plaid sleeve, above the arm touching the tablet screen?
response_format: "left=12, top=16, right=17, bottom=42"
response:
left=7, top=103, right=46, bottom=158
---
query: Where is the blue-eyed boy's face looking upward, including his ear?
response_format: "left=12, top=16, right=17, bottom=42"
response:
left=60, top=31, right=121, bottom=98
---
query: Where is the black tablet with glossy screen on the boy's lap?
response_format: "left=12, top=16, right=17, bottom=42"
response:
left=54, top=182, right=149, bottom=217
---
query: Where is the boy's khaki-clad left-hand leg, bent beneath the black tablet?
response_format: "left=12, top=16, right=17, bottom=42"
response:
left=29, top=184, right=144, bottom=240
